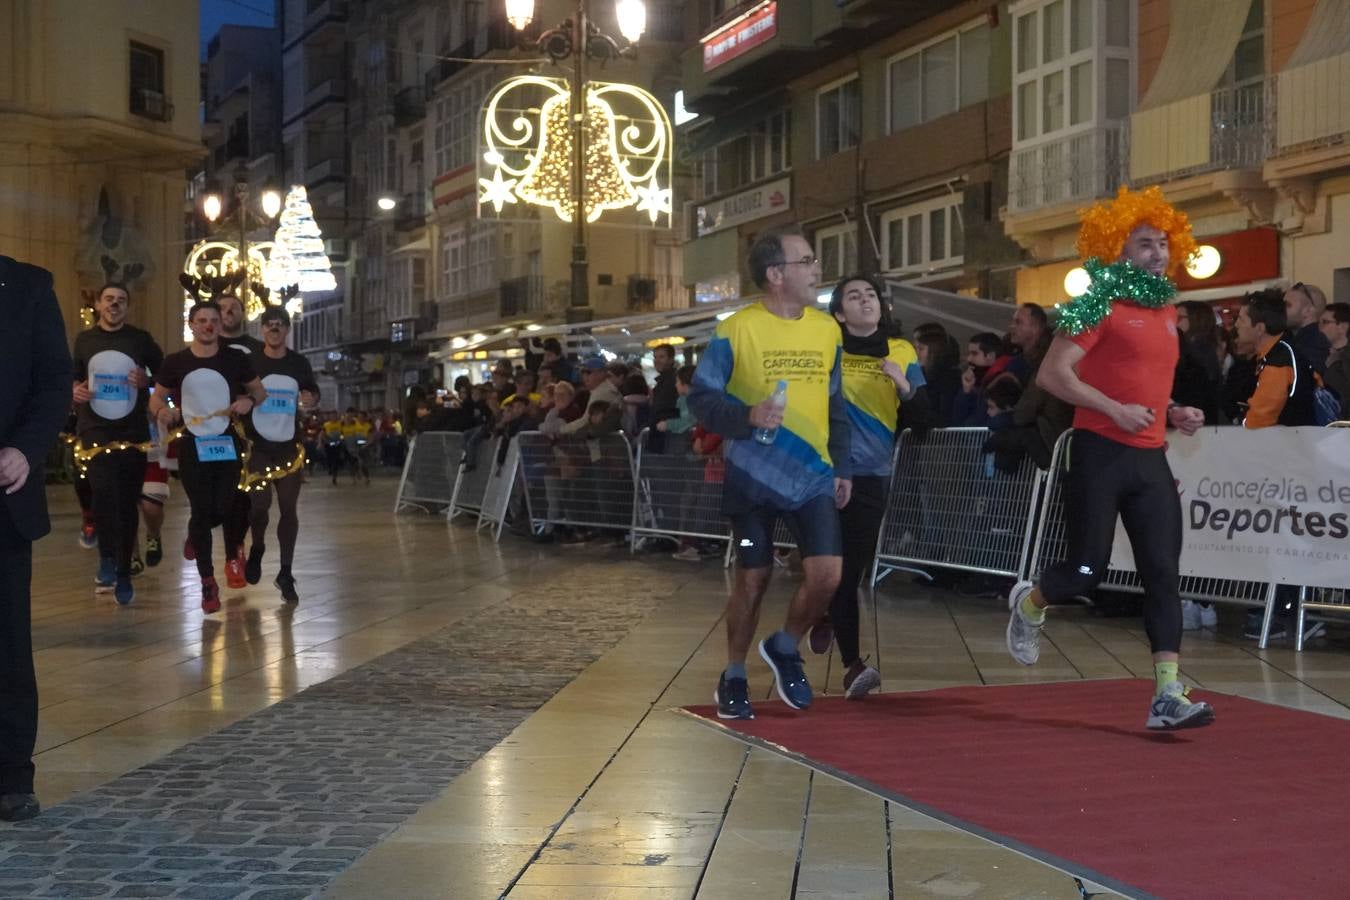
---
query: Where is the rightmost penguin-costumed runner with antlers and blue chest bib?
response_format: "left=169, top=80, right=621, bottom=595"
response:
left=244, top=306, right=319, bottom=603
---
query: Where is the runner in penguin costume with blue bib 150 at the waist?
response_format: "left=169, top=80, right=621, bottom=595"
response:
left=150, top=301, right=267, bottom=614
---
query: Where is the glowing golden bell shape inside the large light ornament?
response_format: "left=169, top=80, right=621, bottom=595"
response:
left=516, top=91, right=637, bottom=221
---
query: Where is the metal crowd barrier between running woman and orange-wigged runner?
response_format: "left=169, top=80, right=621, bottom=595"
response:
left=872, top=428, right=1045, bottom=584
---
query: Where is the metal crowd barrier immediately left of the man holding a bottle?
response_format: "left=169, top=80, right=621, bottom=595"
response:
left=632, top=429, right=732, bottom=546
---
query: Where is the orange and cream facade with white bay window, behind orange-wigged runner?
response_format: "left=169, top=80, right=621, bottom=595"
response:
left=1006, top=0, right=1350, bottom=313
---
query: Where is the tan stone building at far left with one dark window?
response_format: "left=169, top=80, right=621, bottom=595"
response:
left=0, top=0, right=205, bottom=348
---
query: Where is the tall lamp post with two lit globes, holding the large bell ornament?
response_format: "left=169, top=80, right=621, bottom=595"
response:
left=506, top=0, right=647, bottom=322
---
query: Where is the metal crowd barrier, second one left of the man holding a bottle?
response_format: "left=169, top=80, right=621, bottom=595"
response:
left=516, top=432, right=636, bottom=533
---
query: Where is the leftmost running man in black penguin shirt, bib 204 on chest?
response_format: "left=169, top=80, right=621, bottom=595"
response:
left=72, top=285, right=163, bottom=606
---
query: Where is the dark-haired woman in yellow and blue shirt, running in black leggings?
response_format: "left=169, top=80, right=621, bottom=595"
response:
left=810, top=275, right=923, bottom=700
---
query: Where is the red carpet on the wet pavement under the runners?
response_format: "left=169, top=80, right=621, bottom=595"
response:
left=690, top=680, right=1350, bottom=900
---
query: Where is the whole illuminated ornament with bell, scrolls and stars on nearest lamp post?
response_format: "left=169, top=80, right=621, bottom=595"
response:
left=478, top=76, right=672, bottom=228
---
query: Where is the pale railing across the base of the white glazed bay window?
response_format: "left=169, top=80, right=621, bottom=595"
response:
left=1008, top=123, right=1126, bottom=215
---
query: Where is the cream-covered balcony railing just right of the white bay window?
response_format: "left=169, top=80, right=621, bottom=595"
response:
left=1129, top=80, right=1276, bottom=182
